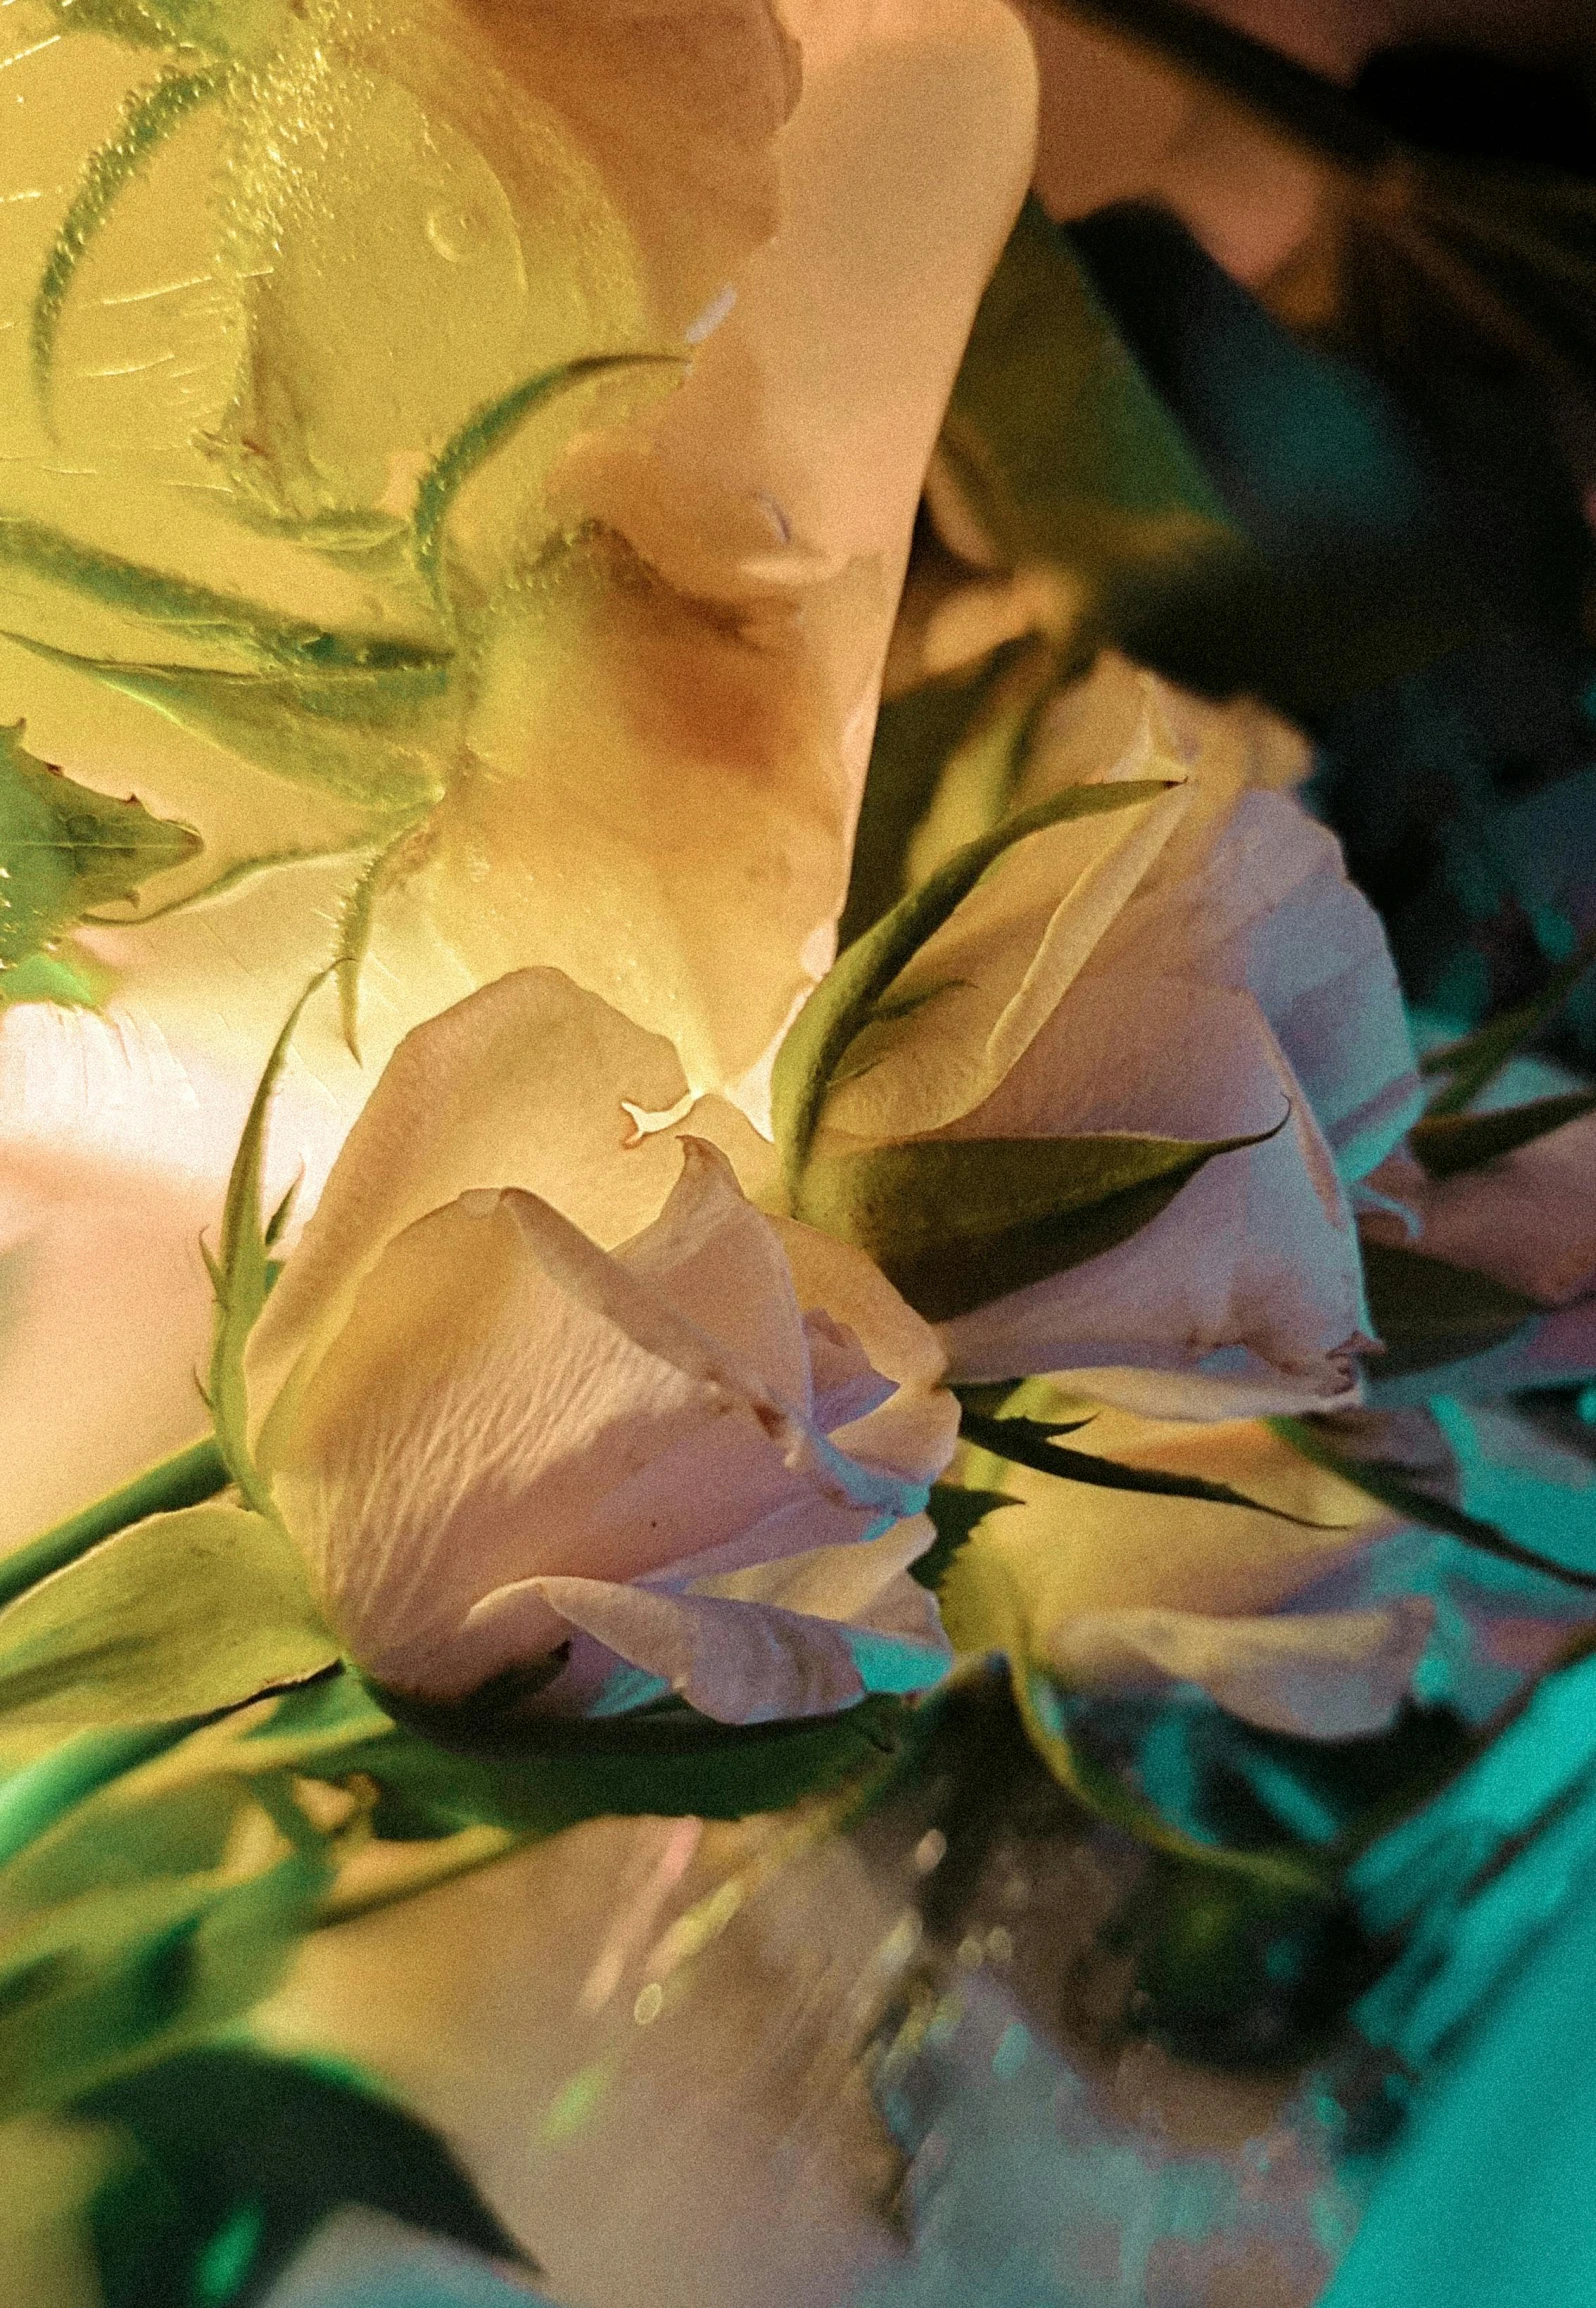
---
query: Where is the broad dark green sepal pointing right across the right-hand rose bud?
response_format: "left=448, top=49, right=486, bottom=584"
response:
left=793, top=1126, right=1268, bottom=1322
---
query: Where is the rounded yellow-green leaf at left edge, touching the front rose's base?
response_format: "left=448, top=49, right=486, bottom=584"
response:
left=0, top=1505, right=339, bottom=1731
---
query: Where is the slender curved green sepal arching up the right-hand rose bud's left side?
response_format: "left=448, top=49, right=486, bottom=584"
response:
left=770, top=778, right=1169, bottom=1207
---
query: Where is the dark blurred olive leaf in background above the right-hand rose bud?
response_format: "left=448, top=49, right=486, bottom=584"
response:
left=941, top=201, right=1245, bottom=630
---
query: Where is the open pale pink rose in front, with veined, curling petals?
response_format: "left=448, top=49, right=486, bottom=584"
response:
left=249, top=972, right=957, bottom=1722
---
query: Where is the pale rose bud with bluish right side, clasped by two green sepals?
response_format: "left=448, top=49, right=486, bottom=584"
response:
left=777, top=688, right=1418, bottom=1415
